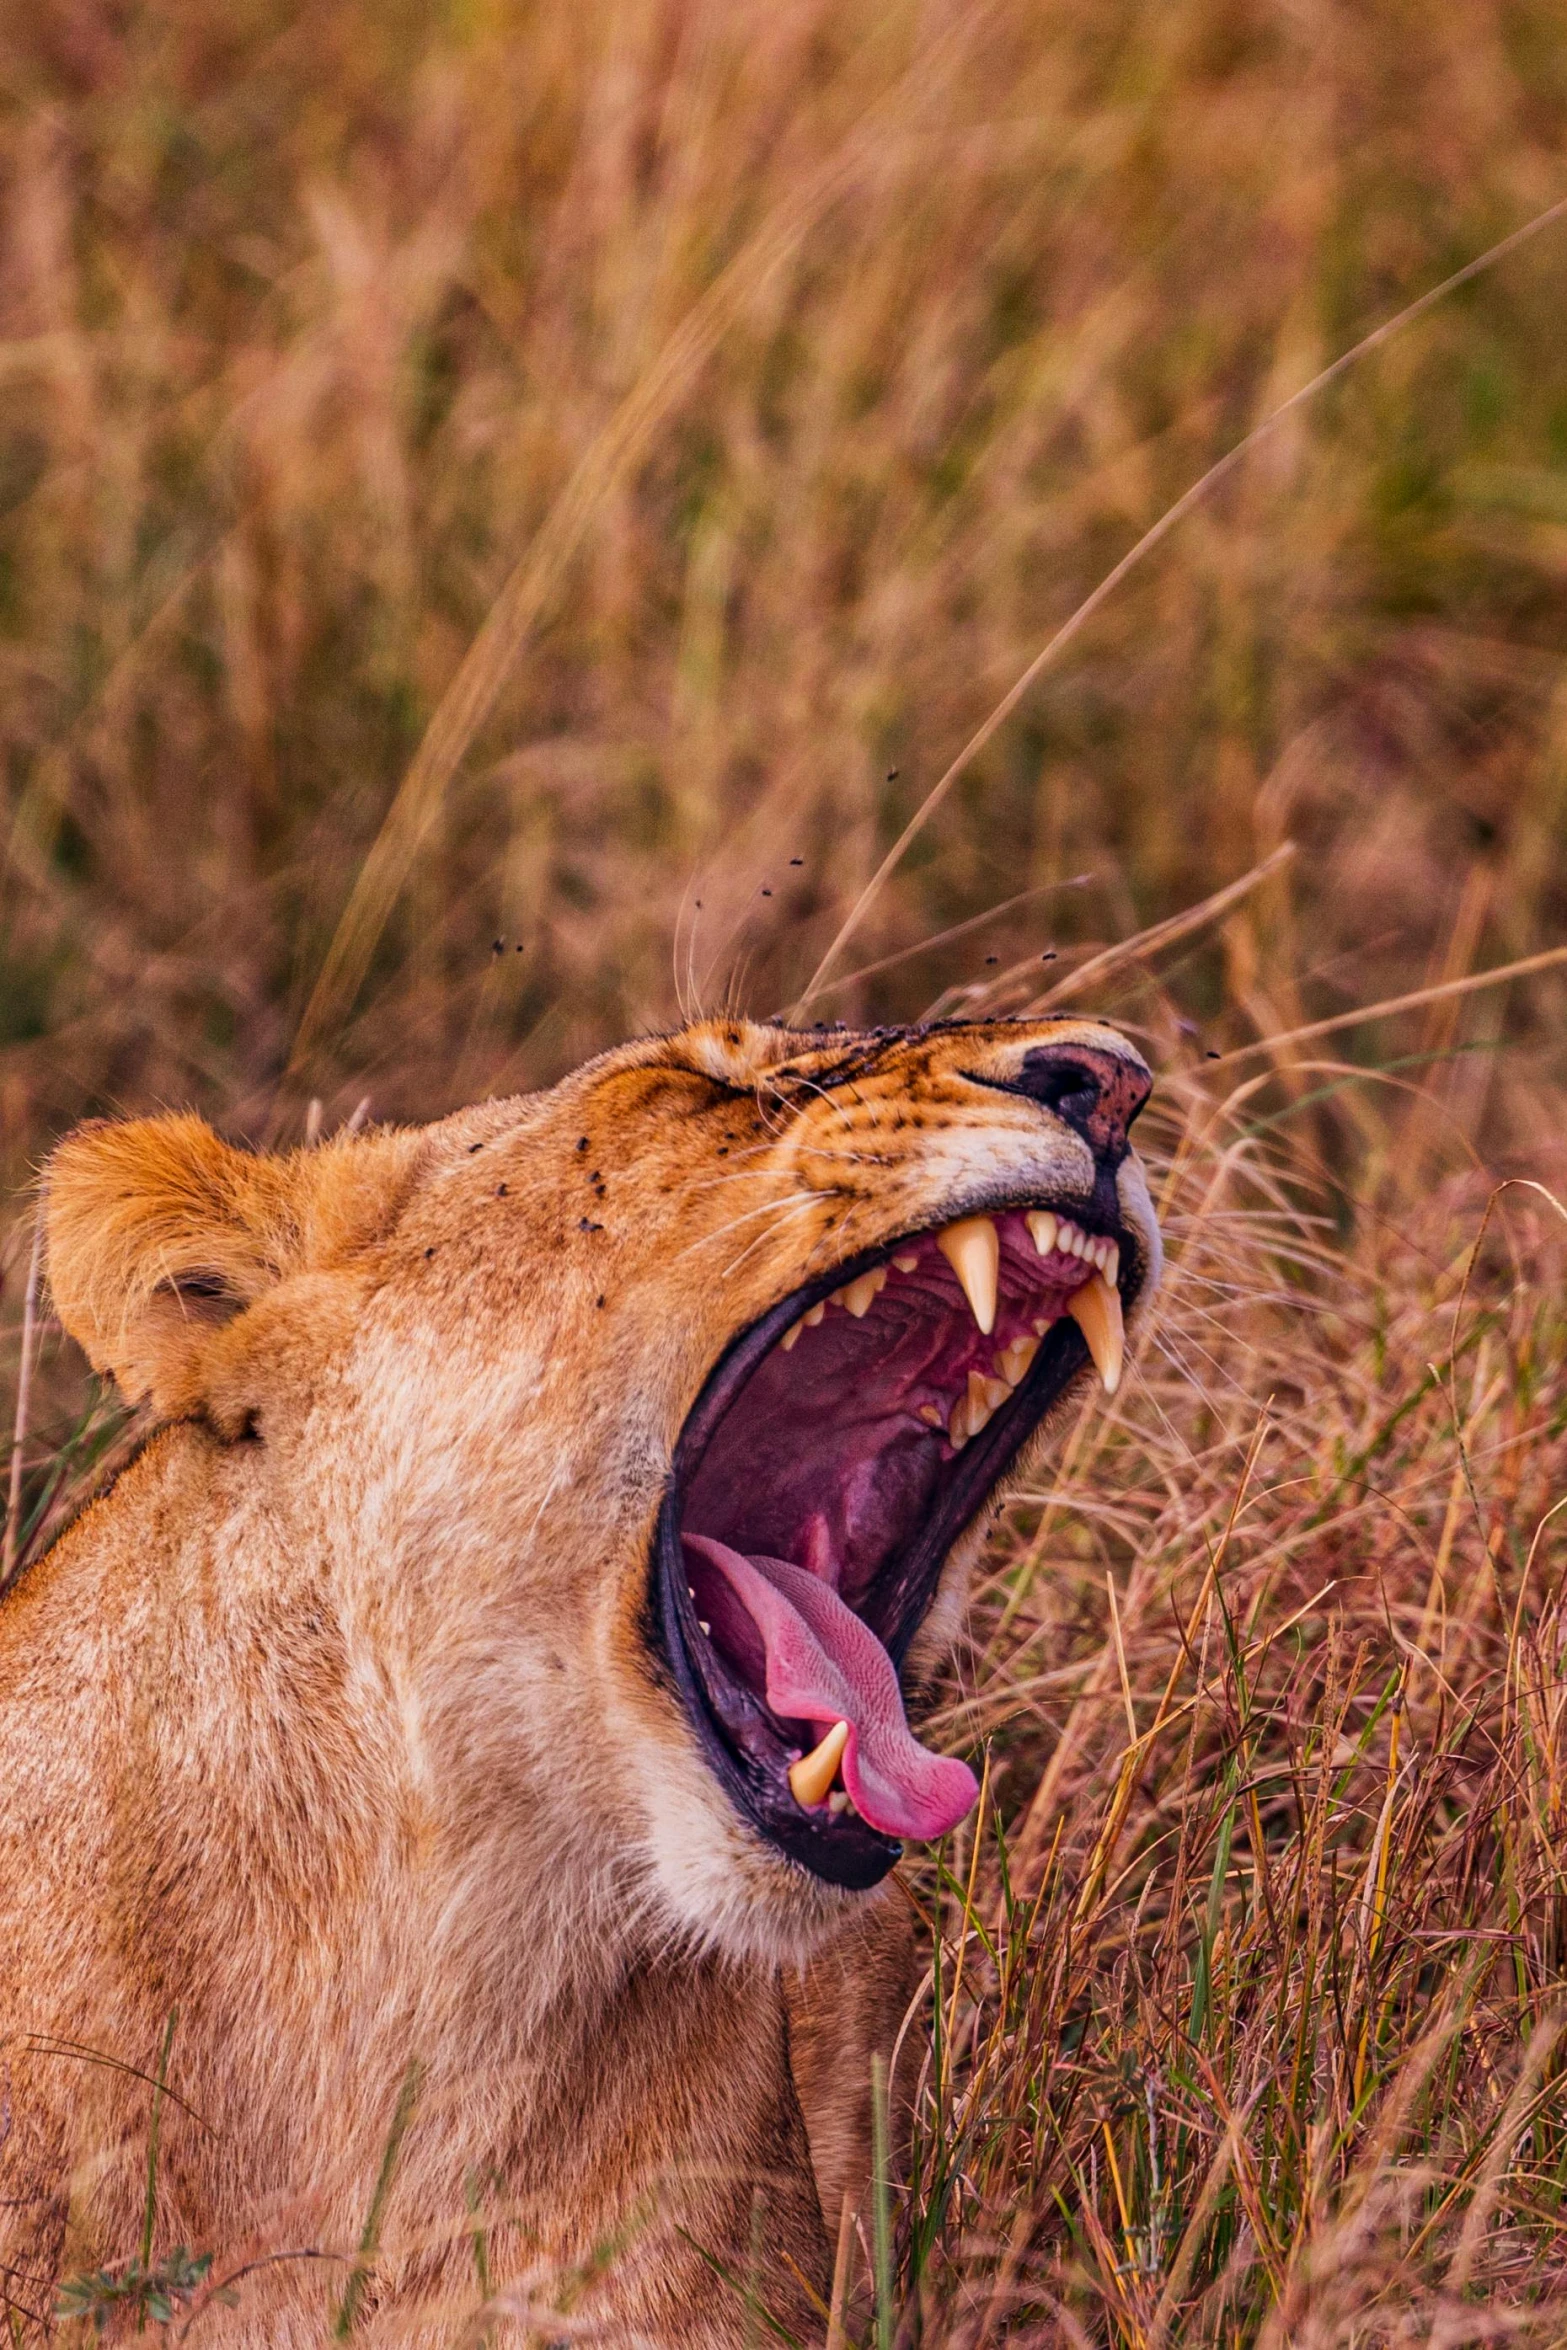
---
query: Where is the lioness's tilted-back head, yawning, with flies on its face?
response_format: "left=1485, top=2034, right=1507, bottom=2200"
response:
left=49, top=1020, right=1161, bottom=1953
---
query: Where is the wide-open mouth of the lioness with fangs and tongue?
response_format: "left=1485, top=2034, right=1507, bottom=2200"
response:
left=653, top=1206, right=1142, bottom=1889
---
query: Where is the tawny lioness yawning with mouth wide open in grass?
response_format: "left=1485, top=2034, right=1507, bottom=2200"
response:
left=0, top=1020, right=1158, bottom=2350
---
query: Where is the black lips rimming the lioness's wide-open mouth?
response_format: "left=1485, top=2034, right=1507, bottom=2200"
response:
left=651, top=1199, right=1144, bottom=1892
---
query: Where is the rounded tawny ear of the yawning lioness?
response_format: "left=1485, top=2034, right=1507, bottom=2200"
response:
left=45, top=1116, right=411, bottom=1417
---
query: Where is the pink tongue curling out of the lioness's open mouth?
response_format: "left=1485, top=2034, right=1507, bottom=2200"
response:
left=684, top=1535, right=980, bottom=1840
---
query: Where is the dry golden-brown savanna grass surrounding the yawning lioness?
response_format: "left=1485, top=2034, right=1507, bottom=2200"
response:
left=0, top=0, right=1567, bottom=2350
